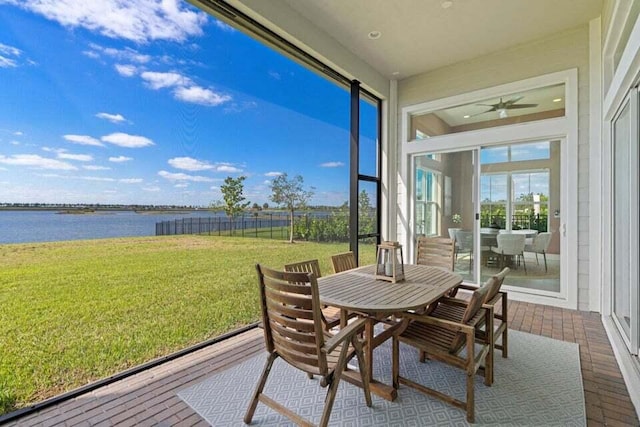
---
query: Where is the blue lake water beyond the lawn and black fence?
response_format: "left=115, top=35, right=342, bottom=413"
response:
left=0, top=211, right=219, bottom=244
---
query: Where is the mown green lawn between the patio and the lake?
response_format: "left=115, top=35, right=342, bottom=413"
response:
left=0, top=236, right=375, bottom=413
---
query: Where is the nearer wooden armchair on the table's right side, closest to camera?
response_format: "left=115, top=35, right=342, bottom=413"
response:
left=392, top=287, right=493, bottom=423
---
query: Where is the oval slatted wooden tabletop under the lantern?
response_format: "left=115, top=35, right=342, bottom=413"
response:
left=318, top=265, right=462, bottom=313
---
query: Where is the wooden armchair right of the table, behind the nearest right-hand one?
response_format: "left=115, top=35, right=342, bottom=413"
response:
left=429, top=267, right=510, bottom=383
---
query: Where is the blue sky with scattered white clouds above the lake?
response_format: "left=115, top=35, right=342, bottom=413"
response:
left=0, top=0, right=377, bottom=206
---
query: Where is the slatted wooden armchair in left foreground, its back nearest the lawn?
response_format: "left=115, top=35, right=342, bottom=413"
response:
left=244, top=264, right=371, bottom=426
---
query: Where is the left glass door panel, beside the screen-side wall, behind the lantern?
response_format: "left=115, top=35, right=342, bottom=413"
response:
left=413, top=150, right=477, bottom=283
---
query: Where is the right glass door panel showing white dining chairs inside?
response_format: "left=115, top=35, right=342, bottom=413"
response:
left=480, top=141, right=561, bottom=295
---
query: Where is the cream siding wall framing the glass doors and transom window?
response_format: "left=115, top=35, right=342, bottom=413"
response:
left=397, top=25, right=597, bottom=310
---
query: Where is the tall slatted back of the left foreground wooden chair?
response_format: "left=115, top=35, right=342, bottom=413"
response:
left=256, top=264, right=328, bottom=376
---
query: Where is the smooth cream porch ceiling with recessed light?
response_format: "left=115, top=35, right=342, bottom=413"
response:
left=282, top=0, right=603, bottom=79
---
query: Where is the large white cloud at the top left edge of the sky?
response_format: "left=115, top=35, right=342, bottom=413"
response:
left=6, top=0, right=207, bottom=43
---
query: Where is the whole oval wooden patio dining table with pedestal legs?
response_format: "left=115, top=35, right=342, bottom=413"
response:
left=318, top=265, right=462, bottom=400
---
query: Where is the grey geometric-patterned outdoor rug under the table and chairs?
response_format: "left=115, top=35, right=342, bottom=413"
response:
left=178, top=331, right=586, bottom=426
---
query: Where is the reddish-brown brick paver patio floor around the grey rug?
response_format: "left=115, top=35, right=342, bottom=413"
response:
left=8, top=302, right=639, bottom=426
